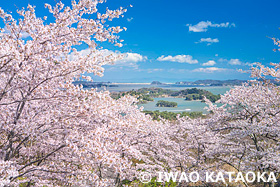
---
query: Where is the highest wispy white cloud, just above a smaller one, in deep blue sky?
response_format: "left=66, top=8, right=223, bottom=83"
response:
left=187, top=21, right=235, bottom=32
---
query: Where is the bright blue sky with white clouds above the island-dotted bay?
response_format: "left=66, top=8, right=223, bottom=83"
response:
left=0, top=0, right=280, bottom=82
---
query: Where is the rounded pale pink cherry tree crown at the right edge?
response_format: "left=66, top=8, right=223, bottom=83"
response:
left=207, top=82, right=280, bottom=172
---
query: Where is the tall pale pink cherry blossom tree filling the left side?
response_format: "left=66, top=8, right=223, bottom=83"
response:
left=0, top=0, right=177, bottom=186
